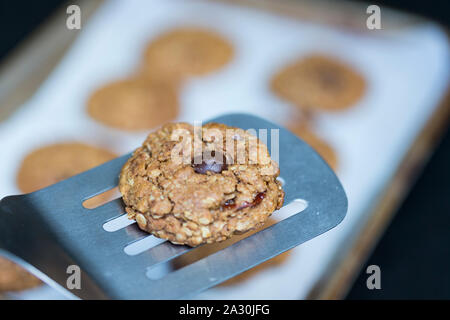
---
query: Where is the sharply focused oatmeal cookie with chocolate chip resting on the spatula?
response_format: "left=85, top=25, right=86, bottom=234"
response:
left=119, top=123, right=284, bottom=246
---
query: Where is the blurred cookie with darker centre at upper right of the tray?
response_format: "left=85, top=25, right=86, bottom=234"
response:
left=271, top=55, right=366, bottom=111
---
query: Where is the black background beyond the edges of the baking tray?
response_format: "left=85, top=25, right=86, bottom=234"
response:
left=0, top=0, right=450, bottom=299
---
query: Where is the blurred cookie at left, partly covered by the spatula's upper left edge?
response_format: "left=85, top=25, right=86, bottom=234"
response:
left=17, top=142, right=117, bottom=207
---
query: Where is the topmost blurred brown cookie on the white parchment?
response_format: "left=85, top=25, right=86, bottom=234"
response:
left=143, top=28, right=233, bottom=79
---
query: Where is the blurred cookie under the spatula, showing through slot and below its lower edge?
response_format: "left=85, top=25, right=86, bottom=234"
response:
left=173, top=218, right=289, bottom=286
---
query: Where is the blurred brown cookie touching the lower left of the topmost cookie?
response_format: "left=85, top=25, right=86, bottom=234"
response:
left=87, top=78, right=179, bottom=130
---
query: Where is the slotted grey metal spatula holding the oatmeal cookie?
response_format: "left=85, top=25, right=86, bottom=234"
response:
left=0, top=114, right=347, bottom=299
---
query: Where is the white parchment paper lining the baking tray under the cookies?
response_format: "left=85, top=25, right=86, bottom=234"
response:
left=0, top=0, right=450, bottom=299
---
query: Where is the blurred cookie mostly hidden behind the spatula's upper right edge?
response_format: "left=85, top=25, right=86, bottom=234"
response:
left=286, top=123, right=338, bottom=170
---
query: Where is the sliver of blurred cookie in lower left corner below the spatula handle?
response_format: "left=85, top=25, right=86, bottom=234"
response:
left=0, top=257, right=41, bottom=292
